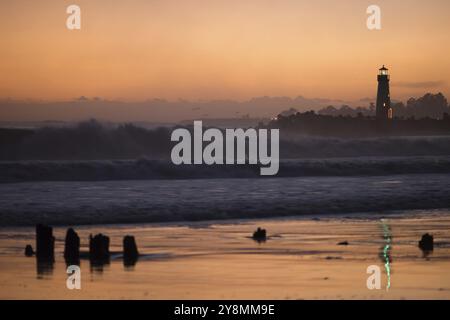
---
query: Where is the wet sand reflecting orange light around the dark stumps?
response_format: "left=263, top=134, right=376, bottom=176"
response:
left=0, top=210, right=450, bottom=299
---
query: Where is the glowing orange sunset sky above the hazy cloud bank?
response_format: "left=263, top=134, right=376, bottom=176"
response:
left=0, top=0, right=450, bottom=100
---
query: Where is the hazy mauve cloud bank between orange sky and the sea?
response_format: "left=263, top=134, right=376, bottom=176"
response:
left=0, top=95, right=442, bottom=123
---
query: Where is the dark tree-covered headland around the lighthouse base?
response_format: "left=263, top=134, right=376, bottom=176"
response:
left=268, top=93, right=450, bottom=137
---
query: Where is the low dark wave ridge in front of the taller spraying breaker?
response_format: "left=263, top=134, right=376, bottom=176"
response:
left=0, top=156, right=450, bottom=183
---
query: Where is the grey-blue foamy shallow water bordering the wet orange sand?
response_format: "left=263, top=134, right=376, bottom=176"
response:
left=0, top=173, right=450, bottom=226
